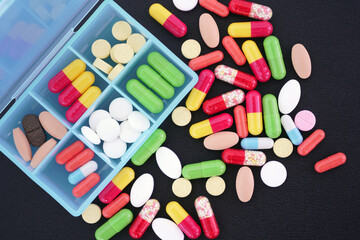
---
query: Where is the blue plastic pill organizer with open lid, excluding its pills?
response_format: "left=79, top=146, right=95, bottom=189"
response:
left=0, top=0, right=198, bottom=216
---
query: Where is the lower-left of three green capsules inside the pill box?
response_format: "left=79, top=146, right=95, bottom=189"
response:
left=126, top=79, right=164, bottom=113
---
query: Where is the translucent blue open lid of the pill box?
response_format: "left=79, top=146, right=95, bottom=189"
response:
left=0, top=0, right=97, bottom=112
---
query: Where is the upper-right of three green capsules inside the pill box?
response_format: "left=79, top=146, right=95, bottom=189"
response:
left=148, top=52, right=185, bottom=87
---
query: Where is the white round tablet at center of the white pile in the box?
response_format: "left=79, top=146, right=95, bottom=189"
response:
left=96, top=118, right=120, bottom=142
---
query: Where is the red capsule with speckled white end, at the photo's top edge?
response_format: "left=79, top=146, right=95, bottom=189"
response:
left=229, top=0, right=273, bottom=21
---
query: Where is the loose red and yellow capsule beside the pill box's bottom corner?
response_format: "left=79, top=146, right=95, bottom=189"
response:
left=99, top=167, right=135, bottom=203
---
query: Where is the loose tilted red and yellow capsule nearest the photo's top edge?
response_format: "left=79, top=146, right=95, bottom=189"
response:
left=149, top=3, right=187, bottom=38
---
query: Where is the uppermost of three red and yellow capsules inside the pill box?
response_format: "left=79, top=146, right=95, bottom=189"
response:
left=48, top=59, right=86, bottom=93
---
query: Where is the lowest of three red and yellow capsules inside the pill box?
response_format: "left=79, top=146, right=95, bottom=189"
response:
left=66, top=86, right=101, bottom=123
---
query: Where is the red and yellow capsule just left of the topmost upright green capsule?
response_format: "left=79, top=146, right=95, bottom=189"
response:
left=242, top=40, right=271, bottom=82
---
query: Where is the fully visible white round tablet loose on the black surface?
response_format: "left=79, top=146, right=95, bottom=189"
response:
left=260, top=161, right=287, bottom=187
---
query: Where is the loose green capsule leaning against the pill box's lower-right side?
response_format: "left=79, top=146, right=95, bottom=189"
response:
left=131, top=128, right=166, bottom=166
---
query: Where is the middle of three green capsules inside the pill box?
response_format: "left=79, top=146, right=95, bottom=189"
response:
left=136, top=65, right=175, bottom=99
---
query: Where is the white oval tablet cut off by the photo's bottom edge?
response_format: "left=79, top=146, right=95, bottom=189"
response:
left=151, top=218, right=184, bottom=240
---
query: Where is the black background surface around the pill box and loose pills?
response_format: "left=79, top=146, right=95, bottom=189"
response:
left=0, top=0, right=360, bottom=239
